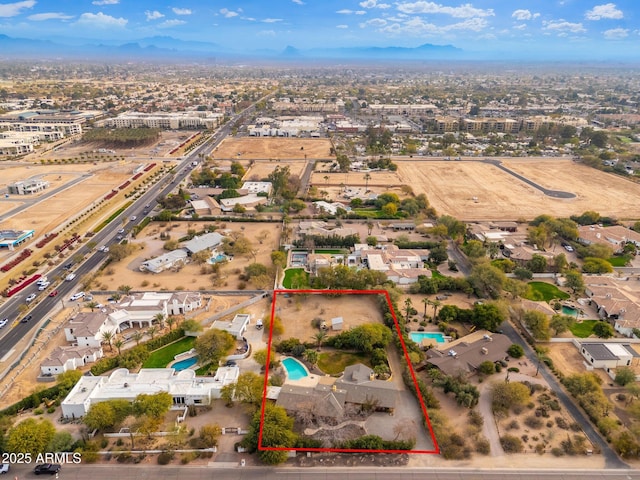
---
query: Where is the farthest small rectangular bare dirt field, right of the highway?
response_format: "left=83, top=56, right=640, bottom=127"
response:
left=213, top=137, right=333, bottom=160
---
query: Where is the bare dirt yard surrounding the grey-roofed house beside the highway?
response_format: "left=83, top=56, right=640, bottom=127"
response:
left=98, top=222, right=279, bottom=290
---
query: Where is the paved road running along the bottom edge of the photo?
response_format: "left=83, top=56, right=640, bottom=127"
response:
left=8, top=463, right=640, bottom=480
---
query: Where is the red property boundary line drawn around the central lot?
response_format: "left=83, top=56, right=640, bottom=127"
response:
left=258, top=290, right=440, bottom=454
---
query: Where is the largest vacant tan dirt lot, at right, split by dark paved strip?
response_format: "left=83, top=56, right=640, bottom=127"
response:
left=392, top=159, right=640, bottom=221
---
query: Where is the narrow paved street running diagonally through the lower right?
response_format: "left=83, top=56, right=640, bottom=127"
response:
left=501, top=322, right=628, bottom=468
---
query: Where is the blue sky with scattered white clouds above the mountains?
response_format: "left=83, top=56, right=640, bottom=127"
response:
left=0, top=0, right=640, bottom=59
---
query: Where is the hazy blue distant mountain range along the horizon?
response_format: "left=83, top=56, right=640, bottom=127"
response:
left=0, top=34, right=468, bottom=63
